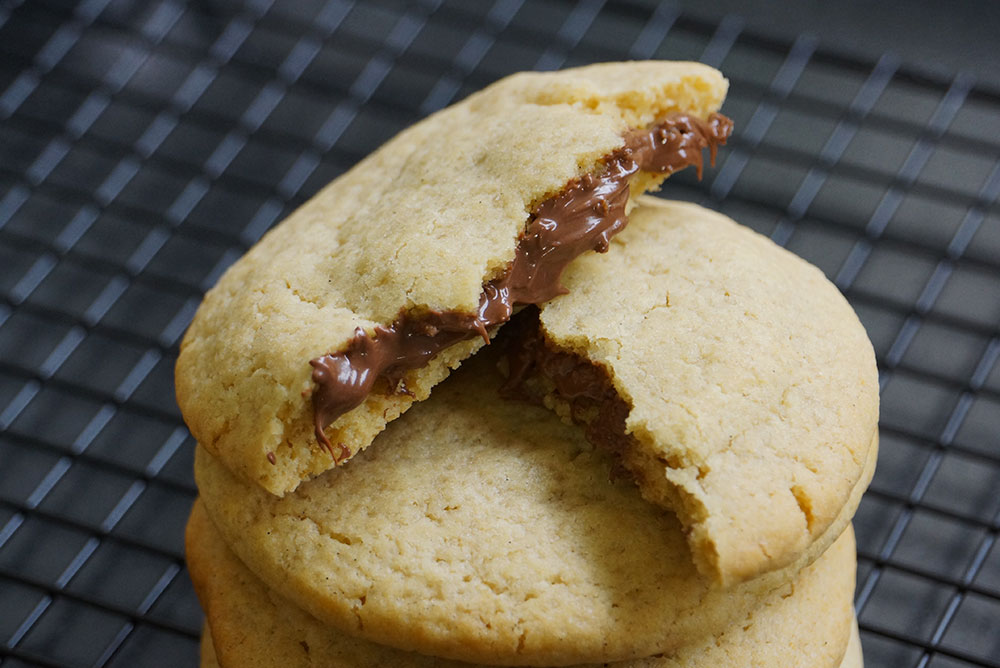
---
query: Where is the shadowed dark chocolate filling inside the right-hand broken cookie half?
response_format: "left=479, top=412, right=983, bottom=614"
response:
left=500, top=308, right=633, bottom=479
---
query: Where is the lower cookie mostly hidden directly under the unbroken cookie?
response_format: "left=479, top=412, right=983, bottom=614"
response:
left=187, top=504, right=861, bottom=668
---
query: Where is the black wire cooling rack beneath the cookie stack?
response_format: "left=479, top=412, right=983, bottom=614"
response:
left=0, top=0, right=1000, bottom=668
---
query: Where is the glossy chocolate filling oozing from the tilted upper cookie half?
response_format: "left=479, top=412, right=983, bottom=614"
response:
left=309, top=114, right=733, bottom=456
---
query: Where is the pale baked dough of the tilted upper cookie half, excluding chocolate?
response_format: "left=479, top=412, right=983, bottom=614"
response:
left=176, top=62, right=726, bottom=494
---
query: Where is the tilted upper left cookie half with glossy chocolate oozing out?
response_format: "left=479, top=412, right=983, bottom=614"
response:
left=176, top=62, right=731, bottom=495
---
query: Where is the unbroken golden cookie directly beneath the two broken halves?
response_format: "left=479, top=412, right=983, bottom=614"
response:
left=195, top=346, right=836, bottom=665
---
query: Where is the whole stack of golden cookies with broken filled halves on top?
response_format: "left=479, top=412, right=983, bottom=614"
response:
left=177, top=62, right=878, bottom=668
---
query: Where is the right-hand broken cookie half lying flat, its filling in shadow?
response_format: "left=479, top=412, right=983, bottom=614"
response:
left=498, top=196, right=878, bottom=584
